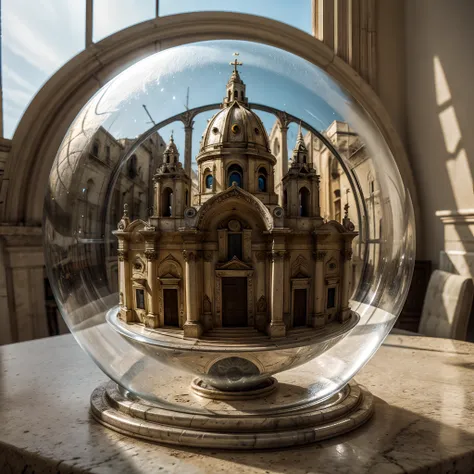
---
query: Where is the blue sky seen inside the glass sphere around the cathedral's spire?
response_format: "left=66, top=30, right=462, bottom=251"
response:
left=73, top=40, right=347, bottom=170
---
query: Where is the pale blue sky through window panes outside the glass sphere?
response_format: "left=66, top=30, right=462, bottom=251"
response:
left=0, top=0, right=311, bottom=138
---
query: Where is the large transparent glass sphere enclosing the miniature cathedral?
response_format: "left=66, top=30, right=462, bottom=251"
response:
left=44, top=40, right=415, bottom=409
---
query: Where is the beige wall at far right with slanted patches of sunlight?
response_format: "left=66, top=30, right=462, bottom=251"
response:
left=406, top=0, right=474, bottom=267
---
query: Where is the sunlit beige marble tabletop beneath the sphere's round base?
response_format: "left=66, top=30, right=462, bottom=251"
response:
left=0, top=335, right=474, bottom=474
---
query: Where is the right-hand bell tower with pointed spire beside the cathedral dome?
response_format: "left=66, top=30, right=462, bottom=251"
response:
left=282, top=124, right=321, bottom=217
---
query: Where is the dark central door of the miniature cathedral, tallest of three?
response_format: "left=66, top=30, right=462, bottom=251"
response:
left=222, top=277, right=248, bottom=327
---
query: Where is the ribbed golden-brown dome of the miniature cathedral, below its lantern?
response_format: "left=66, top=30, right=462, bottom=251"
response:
left=200, top=100, right=270, bottom=153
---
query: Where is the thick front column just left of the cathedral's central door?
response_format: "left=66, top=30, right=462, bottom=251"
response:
left=183, top=250, right=202, bottom=337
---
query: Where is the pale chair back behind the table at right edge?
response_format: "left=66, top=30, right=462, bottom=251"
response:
left=392, top=270, right=474, bottom=341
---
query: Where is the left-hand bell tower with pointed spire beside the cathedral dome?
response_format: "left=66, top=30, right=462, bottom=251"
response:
left=153, top=134, right=191, bottom=218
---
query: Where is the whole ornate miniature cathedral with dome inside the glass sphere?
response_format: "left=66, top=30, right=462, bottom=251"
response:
left=114, top=61, right=357, bottom=338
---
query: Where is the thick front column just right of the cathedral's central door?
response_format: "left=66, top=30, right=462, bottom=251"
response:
left=268, top=250, right=286, bottom=338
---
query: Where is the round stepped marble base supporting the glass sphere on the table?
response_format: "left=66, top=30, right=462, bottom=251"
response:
left=91, top=381, right=373, bottom=450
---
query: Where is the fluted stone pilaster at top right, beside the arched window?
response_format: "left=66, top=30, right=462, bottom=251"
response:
left=313, top=0, right=377, bottom=90
